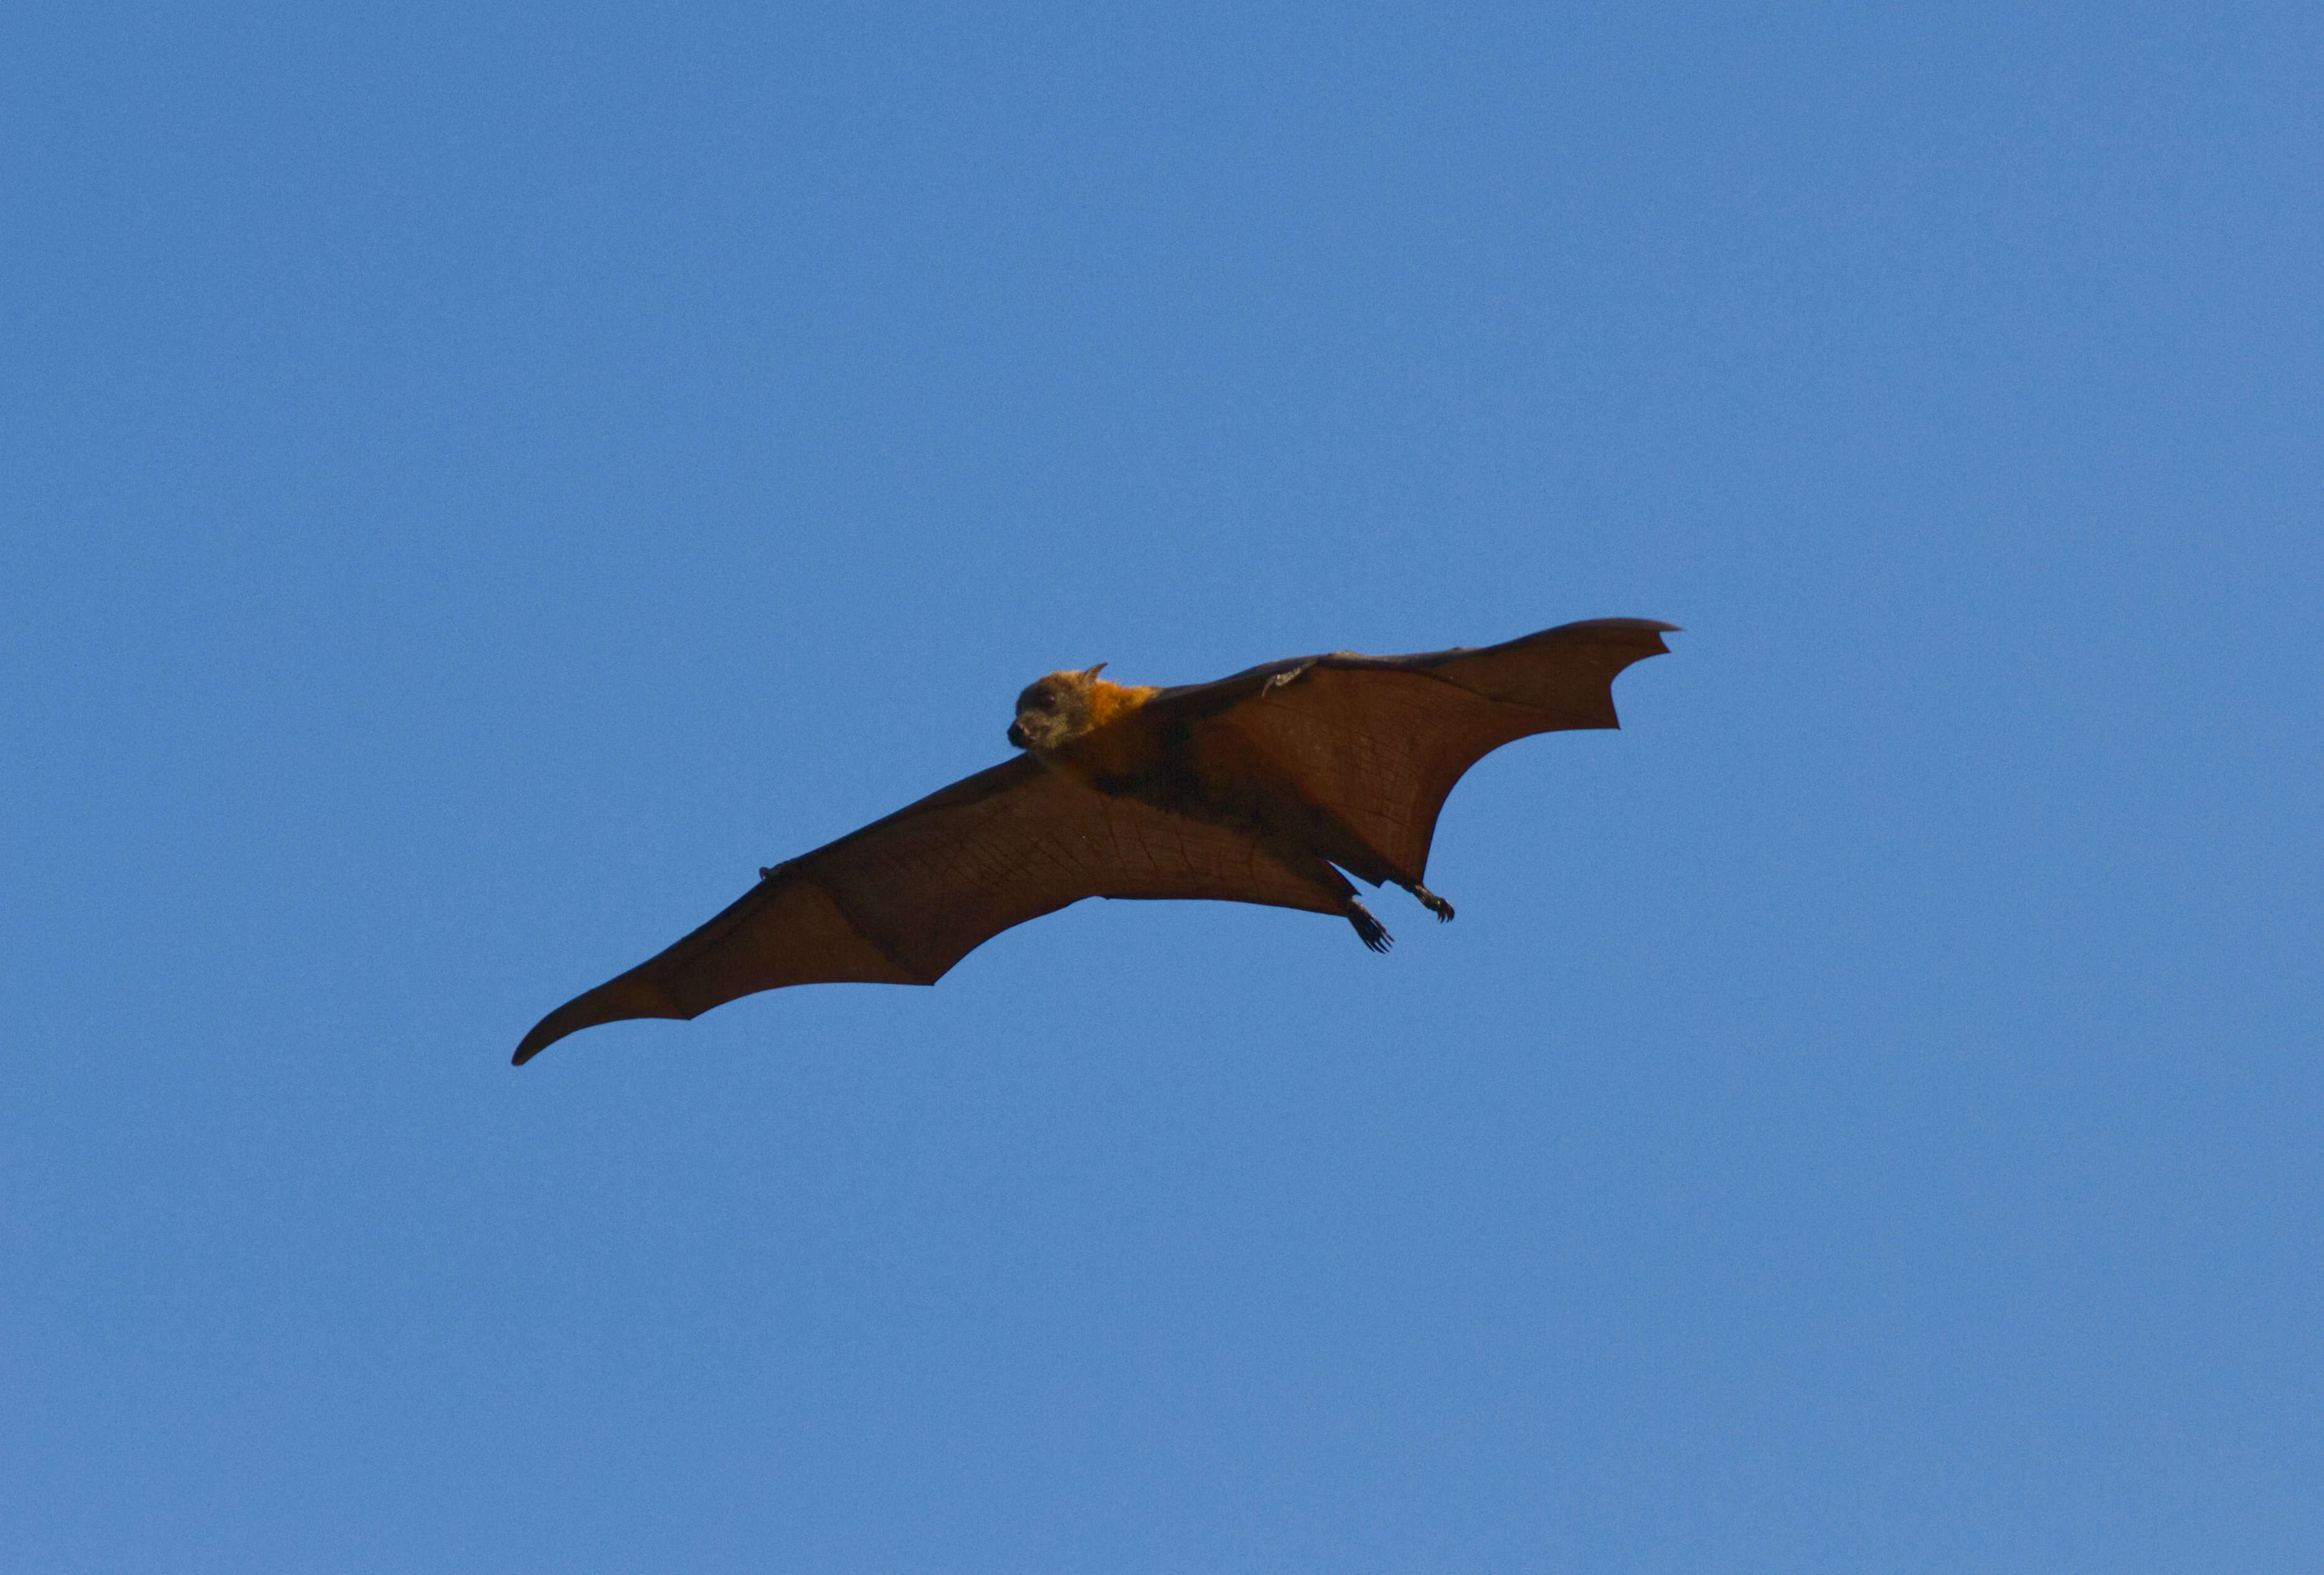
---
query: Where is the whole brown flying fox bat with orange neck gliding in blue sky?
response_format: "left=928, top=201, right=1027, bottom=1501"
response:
left=516, top=618, right=1678, bottom=1066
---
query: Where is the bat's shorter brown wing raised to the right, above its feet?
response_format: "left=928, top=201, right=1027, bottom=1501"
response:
left=1150, top=618, right=1678, bottom=885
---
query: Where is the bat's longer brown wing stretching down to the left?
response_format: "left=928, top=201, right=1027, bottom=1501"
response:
left=514, top=757, right=1336, bottom=1066
